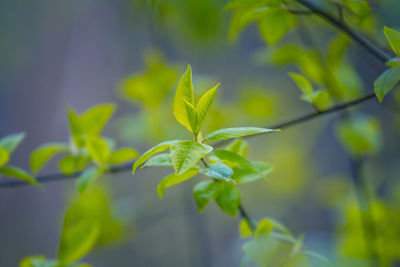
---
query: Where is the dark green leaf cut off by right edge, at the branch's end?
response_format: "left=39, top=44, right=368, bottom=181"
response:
left=374, top=67, right=400, bottom=102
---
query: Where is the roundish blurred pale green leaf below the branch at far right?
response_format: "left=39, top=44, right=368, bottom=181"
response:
left=336, top=116, right=382, bottom=156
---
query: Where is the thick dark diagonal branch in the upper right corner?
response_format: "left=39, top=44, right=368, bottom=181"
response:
left=296, top=0, right=392, bottom=63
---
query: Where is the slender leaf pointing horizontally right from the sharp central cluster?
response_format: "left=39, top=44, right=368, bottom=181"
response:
left=204, top=127, right=280, bottom=141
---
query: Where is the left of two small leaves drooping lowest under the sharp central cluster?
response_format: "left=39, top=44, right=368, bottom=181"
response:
left=193, top=181, right=223, bottom=212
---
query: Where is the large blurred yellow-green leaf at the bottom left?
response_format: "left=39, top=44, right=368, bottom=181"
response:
left=58, top=220, right=100, bottom=263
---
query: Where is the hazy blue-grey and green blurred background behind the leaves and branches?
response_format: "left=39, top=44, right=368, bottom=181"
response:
left=0, top=0, right=400, bottom=267
